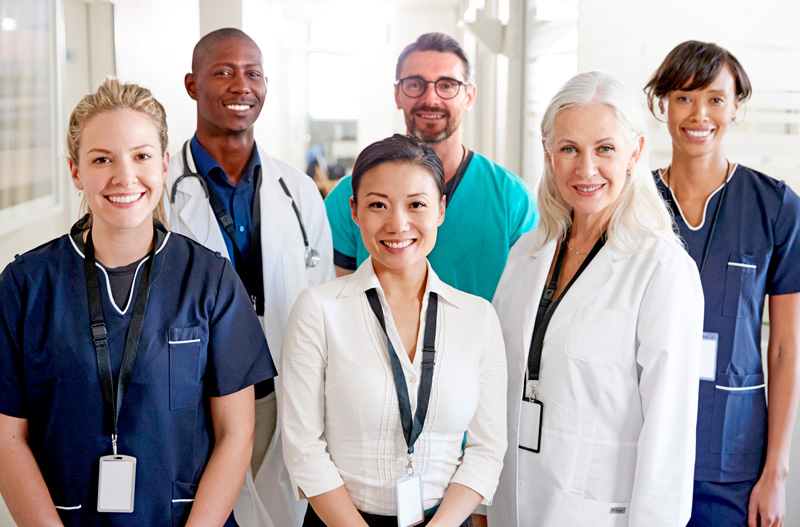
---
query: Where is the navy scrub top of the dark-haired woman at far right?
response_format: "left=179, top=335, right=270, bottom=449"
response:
left=654, top=165, right=800, bottom=482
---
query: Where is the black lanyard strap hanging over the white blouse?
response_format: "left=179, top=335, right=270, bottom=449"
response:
left=367, top=288, right=439, bottom=456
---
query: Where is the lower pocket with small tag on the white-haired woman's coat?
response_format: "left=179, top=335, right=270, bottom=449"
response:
left=542, top=487, right=631, bottom=527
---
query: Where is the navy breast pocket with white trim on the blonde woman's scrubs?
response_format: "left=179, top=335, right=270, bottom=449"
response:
left=169, top=326, right=203, bottom=410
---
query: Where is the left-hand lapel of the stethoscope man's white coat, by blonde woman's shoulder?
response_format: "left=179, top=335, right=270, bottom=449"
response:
left=175, top=151, right=231, bottom=260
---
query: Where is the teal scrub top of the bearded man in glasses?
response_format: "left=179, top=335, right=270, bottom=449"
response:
left=325, top=153, right=538, bottom=302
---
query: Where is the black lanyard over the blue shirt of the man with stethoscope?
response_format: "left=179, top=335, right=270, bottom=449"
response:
left=183, top=141, right=264, bottom=316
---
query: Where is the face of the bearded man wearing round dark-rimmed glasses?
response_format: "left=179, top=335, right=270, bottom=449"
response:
left=394, top=51, right=476, bottom=143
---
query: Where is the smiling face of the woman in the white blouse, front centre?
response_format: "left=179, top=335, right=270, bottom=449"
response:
left=350, top=162, right=444, bottom=270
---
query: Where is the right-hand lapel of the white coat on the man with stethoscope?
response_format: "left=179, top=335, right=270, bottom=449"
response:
left=258, top=149, right=292, bottom=291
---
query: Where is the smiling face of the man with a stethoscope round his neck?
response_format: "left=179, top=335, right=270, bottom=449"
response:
left=184, top=38, right=267, bottom=136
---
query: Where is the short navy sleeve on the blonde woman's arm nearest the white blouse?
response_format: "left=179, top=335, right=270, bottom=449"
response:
left=205, top=258, right=277, bottom=397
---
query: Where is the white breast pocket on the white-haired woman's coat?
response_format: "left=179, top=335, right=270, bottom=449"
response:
left=566, top=305, right=628, bottom=366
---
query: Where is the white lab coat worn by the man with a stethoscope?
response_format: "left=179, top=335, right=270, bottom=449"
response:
left=167, top=142, right=335, bottom=527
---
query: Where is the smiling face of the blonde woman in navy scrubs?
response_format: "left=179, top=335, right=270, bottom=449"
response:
left=70, top=109, right=169, bottom=237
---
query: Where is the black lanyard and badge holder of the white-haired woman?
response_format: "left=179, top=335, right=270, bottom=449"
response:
left=518, top=231, right=606, bottom=454
